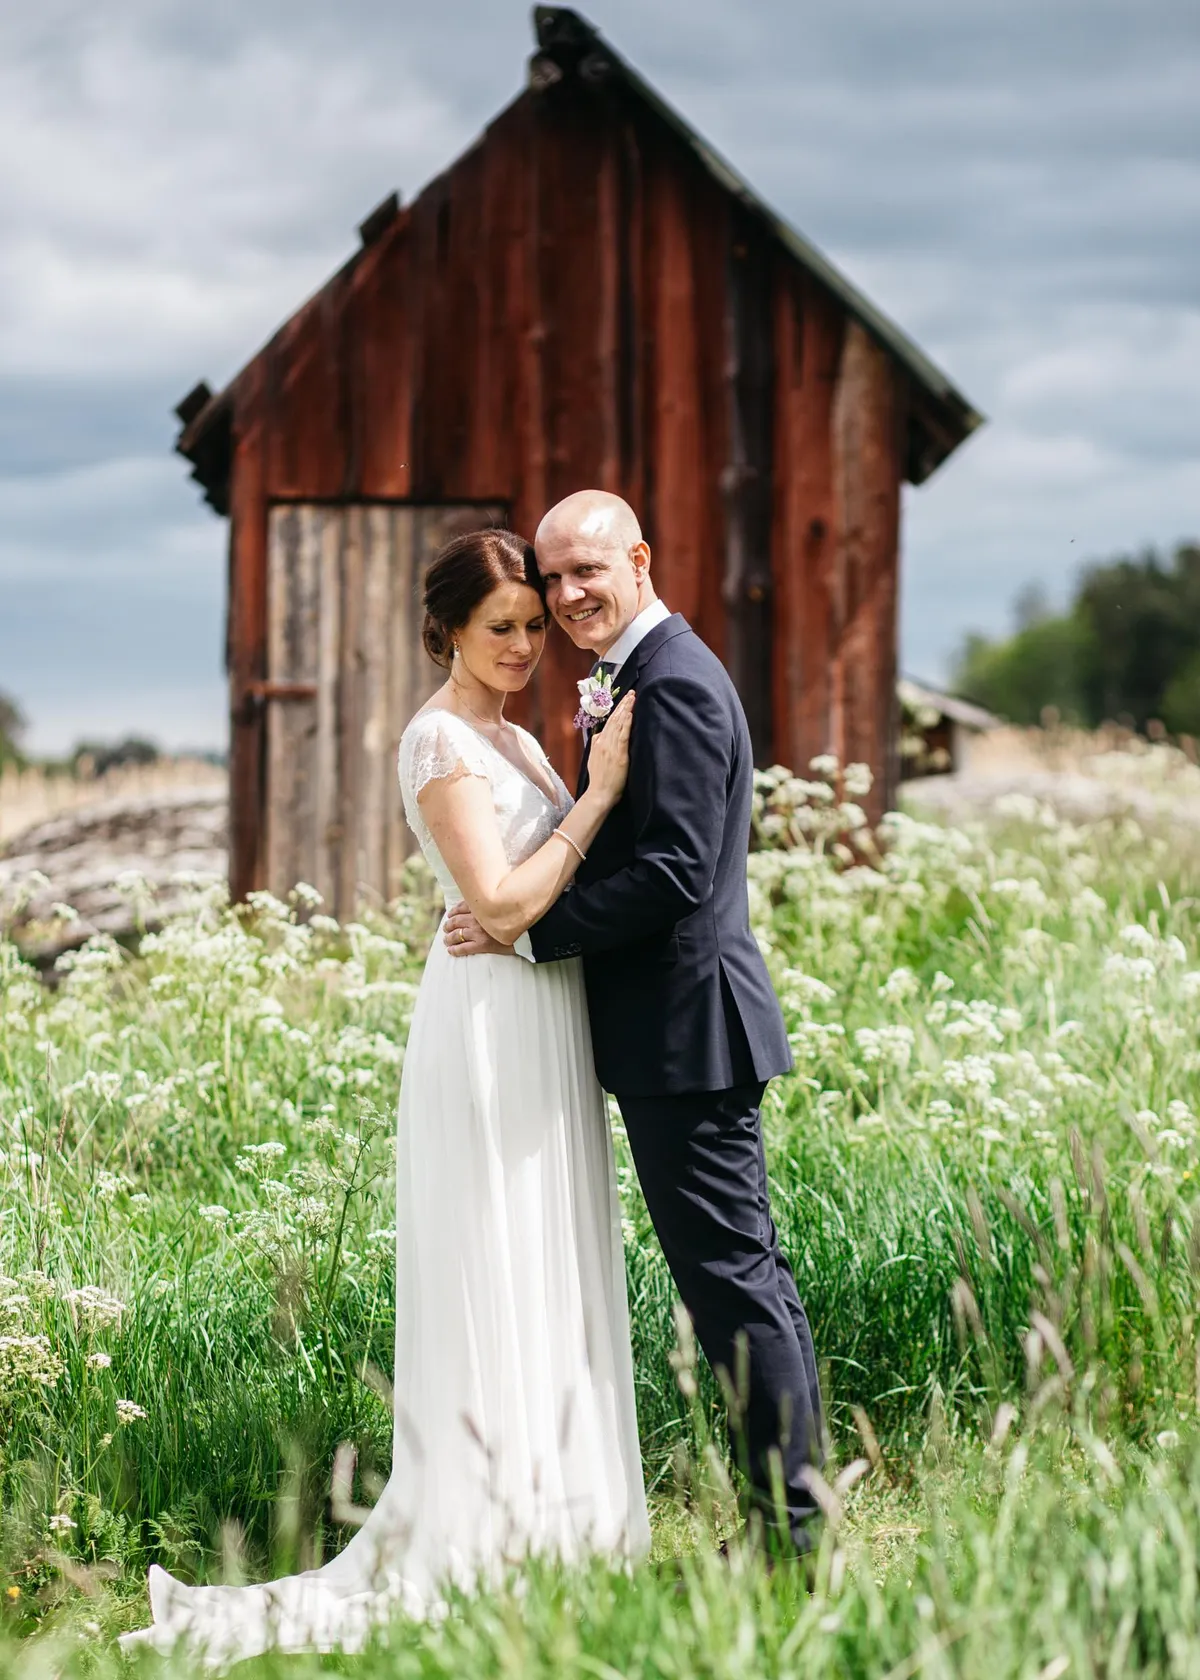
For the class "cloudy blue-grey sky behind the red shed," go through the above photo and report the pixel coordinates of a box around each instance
[0,0,1200,751]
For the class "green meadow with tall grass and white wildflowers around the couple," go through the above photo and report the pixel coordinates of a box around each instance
[0,749,1200,1680]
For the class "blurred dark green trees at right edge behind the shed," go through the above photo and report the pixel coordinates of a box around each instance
[955,543,1200,736]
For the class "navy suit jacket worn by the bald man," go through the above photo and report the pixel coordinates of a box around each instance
[529,613,792,1097]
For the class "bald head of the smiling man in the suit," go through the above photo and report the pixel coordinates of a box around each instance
[533,491,654,654]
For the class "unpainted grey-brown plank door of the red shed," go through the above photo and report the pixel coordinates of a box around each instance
[262,502,506,919]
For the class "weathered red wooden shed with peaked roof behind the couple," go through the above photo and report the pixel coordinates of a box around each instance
[178,7,980,916]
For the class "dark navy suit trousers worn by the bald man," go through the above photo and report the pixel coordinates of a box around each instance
[615,1084,824,1551]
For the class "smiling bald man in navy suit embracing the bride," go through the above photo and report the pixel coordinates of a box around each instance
[445,491,822,1551]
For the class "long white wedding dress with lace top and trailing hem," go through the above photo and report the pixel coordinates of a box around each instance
[121,709,650,1667]
